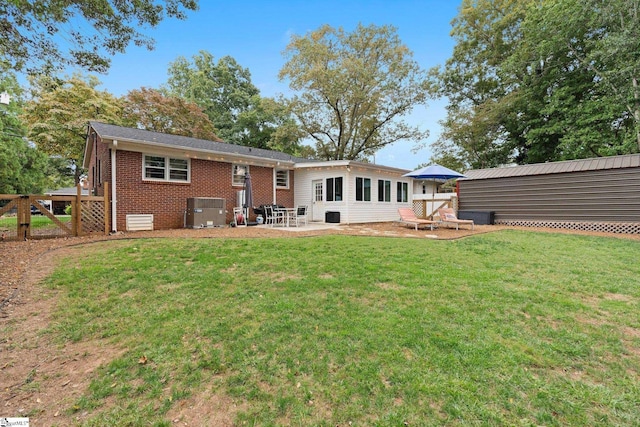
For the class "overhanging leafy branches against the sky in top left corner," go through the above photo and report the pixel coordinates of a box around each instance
[0,0,198,74]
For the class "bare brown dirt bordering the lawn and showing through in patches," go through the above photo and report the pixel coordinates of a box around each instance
[0,223,640,426]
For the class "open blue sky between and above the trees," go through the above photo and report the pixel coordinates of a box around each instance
[98,0,460,170]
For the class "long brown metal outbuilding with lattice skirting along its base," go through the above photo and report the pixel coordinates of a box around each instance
[458,154,640,233]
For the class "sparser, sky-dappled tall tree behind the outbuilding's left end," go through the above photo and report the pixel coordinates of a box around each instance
[430,0,530,168]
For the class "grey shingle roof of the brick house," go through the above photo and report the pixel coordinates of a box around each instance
[89,122,311,166]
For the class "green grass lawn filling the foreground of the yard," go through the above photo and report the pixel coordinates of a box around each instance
[47,231,640,426]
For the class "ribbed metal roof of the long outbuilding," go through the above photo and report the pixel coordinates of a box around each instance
[461,154,640,180]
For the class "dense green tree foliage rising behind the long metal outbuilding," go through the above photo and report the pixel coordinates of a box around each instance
[431,0,640,168]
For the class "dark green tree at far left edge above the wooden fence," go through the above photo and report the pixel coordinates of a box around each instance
[0,70,48,194]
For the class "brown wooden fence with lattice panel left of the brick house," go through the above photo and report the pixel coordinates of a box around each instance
[0,184,110,240]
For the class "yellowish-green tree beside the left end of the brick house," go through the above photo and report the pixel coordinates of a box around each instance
[23,75,122,185]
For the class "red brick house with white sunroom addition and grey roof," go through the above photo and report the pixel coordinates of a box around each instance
[83,122,412,231]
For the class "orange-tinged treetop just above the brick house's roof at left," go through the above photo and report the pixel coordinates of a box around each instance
[122,88,220,141]
